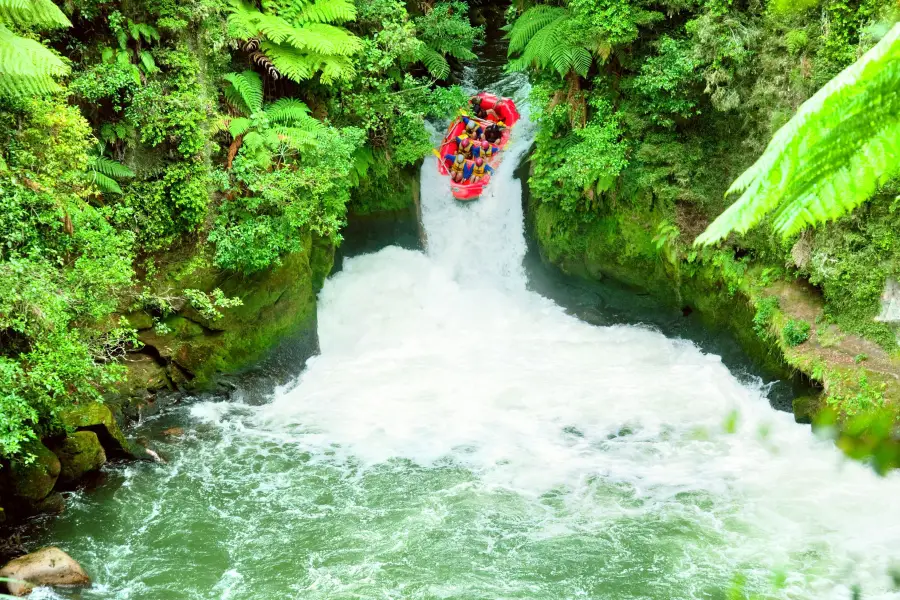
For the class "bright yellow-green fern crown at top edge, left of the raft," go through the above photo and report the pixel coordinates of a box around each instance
[228,0,361,83]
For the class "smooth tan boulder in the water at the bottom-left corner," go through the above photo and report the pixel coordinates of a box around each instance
[0,546,91,596]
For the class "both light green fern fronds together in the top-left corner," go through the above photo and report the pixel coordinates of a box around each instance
[0,0,72,98]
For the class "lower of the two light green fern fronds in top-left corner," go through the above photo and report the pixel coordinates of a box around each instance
[0,23,69,98]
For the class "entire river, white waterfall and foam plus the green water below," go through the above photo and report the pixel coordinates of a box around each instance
[26,72,900,600]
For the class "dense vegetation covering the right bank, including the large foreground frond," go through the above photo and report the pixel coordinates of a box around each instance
[506,0,900,468]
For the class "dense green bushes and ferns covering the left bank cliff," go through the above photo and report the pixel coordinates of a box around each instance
[0,0,481,458]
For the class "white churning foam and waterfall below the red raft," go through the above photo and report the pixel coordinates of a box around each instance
[248,86,900,598]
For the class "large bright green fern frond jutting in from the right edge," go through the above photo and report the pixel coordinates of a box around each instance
[696,24,900,244]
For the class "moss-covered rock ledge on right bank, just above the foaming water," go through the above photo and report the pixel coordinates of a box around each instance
[531,196,900,419]
